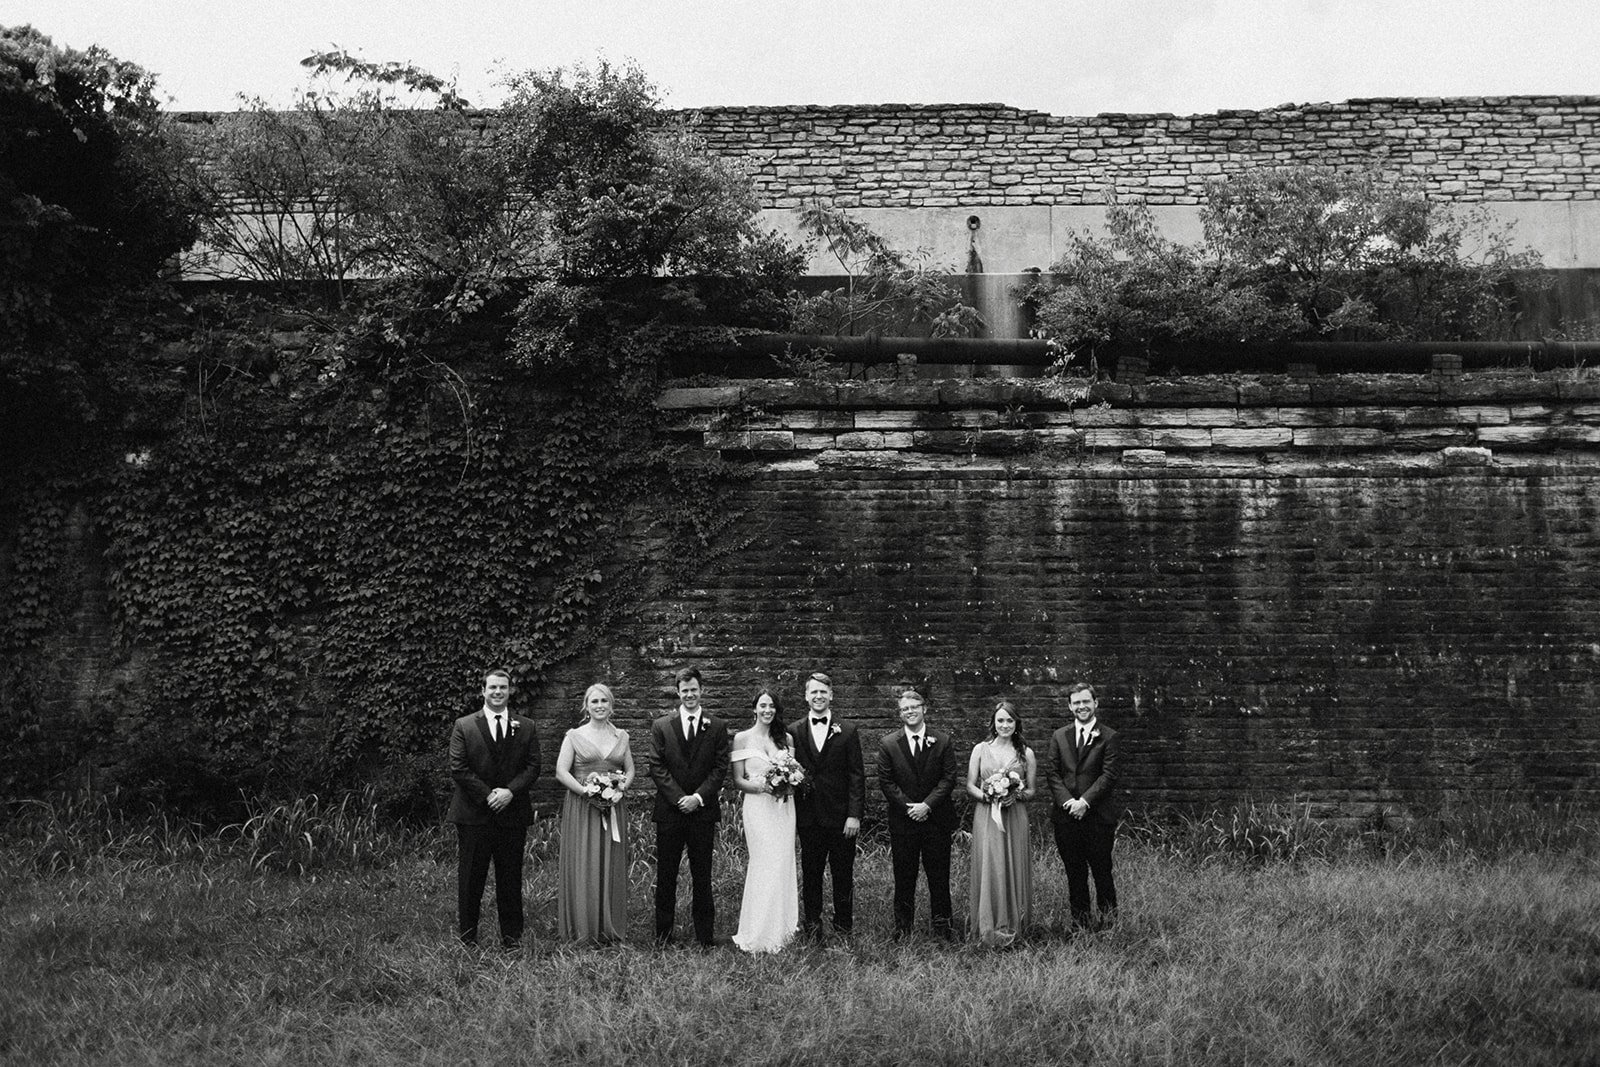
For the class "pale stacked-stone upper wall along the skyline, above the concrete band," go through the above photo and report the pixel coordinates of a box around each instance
[691,96,1600,208]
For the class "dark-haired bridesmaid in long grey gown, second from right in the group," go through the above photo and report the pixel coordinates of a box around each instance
[966,701,1037,947]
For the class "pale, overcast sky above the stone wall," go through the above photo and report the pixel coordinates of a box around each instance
[12,0,1600,115]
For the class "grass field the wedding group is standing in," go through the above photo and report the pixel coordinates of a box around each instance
[0,800,1600,1065]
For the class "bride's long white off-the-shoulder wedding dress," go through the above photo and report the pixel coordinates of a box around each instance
[730,749,800,952]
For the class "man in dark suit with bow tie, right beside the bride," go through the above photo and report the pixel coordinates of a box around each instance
[789,673,867,939]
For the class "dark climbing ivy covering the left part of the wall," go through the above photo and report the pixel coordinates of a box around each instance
[6,295,726,816]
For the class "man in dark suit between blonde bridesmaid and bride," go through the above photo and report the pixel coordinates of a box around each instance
[650,667,733,949]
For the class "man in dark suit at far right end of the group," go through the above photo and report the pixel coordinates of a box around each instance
[1046,681,1122,929]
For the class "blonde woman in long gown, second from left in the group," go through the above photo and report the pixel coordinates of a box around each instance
[555,685,634,944]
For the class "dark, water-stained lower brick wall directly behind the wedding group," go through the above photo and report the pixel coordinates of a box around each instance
[534,374,1600,817]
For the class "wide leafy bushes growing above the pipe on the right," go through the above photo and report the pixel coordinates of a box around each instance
[1027,166,1539,363]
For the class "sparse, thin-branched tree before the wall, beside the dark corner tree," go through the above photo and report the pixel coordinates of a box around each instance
[195,50,538,318]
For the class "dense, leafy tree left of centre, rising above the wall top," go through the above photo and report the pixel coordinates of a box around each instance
[494,61,803,376]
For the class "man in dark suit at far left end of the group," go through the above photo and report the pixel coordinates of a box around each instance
[448,667,539,949]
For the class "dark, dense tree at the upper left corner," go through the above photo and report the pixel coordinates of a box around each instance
[0,26,202,480]
